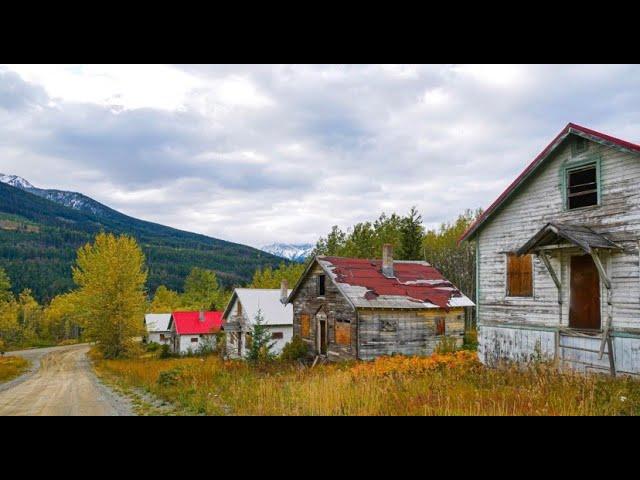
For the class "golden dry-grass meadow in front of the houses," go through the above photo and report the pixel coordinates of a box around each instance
[94,351,640,415]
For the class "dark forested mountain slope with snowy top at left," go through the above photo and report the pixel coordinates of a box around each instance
[0,175,282,301]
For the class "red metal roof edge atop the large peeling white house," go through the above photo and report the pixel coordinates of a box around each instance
[458,123,640,242]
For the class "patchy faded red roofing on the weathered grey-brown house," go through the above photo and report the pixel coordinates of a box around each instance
[319,257,461,309]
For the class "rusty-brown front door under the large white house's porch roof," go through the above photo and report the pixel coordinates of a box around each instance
[569,255,600,330]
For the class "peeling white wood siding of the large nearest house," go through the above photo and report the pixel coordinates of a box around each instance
[476,137,640,371]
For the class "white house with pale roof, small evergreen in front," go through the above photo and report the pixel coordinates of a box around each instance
[222,281,293,358]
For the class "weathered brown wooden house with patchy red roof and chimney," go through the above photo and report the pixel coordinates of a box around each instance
[288,245,473,360]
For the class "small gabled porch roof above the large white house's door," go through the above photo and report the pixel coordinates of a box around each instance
[516,222,620,255]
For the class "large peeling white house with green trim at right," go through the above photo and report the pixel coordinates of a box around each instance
[461,124,640,374]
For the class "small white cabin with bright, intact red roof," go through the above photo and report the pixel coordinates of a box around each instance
[169,312,222,355]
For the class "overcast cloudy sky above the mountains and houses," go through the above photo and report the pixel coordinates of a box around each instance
[0,65,640,246]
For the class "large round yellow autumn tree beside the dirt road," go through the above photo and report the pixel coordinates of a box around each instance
[73,233,147,358]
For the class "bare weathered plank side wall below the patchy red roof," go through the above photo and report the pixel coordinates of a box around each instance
[358,308,464,360]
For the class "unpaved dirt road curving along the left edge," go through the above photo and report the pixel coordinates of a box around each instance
[0,345,132,416]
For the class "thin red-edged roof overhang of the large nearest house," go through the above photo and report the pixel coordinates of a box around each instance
[458,123,640,243]
